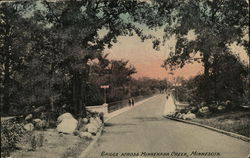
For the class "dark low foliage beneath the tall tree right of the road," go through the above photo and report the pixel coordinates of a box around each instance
[174,54,249,110]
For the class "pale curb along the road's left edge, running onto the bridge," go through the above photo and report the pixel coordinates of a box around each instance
[78,95,158,158]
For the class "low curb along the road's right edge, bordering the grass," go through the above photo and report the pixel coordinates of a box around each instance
[163,116,250,142]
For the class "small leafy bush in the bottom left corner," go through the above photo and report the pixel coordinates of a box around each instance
[1,120,24,157]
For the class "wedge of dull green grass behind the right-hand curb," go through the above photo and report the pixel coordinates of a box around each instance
[192,111,250,137]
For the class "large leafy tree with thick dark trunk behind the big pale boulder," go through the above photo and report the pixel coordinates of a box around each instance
[1,0,156,115]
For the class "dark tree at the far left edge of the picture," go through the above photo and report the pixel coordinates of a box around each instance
[0,3,31,112]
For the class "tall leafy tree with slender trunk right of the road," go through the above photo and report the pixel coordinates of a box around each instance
[156,0,249,101]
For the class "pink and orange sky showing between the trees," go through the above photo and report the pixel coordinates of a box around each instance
[104,27,248,80]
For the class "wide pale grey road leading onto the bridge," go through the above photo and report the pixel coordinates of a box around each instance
[84,95,250,158]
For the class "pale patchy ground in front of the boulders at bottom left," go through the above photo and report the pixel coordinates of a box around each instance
[11,129,91,158]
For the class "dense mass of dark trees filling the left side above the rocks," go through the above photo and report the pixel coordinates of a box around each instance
[0,0,168,115]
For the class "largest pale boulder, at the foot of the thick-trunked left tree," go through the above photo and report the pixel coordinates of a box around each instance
[56,118,78,134]
